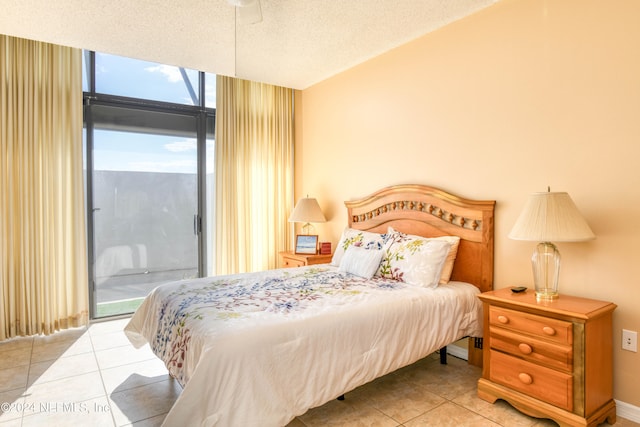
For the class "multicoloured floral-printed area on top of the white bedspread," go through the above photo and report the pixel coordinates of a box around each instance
[150,267,405,385]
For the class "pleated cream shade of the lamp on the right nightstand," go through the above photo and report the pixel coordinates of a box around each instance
[509,192,596,242]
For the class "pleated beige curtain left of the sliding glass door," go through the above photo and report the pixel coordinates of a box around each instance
[0,35,88,339]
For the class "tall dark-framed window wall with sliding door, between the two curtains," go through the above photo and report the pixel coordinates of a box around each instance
[83,52,215,318]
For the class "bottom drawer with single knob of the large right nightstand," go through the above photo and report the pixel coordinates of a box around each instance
[490,350,573,411]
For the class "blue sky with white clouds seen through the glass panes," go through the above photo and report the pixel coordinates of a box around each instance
[84,52,216,173]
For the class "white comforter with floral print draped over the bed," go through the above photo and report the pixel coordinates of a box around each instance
[125,265,482,427]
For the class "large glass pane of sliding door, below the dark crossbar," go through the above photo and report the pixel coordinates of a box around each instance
[92,127,199,317]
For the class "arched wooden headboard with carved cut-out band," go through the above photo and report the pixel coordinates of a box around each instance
[345,184,495,292]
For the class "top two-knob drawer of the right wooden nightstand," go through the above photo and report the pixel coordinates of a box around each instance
[489,306,573,345]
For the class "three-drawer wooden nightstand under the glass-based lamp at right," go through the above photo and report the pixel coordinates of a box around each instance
[478,288,616,426]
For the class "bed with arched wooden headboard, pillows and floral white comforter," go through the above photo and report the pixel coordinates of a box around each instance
[125,185,495,426]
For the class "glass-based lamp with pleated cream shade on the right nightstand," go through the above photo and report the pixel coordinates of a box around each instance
[509,191,596,300]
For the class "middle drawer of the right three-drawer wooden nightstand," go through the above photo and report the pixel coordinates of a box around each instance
[489,327,573,373]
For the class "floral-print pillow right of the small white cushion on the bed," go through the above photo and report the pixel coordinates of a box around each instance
[377,232,451,288]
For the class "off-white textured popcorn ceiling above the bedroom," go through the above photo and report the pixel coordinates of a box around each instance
[0,0,498,89]
